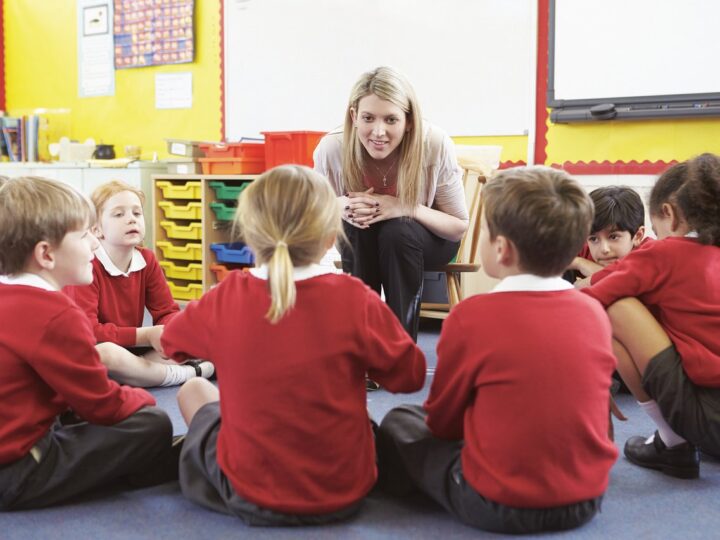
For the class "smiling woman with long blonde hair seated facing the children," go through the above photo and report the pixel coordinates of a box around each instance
[314,67,468,339]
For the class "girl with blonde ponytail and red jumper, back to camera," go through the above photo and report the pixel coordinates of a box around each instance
[162,166,425,525]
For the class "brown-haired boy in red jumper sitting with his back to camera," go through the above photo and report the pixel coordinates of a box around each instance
[377,167,617,533]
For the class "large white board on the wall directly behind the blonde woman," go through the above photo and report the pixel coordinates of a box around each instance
[223,0,537,140]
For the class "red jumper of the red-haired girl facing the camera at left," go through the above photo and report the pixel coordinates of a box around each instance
[64,248,180,347]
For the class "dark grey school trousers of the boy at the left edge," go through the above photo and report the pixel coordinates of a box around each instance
[0,407,172,510]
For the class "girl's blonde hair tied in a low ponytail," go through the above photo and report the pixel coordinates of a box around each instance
[234,165,342,323]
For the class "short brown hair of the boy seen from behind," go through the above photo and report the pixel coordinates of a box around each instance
[483,166,594,277]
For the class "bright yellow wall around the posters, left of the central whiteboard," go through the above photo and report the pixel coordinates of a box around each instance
[3,0,221,159]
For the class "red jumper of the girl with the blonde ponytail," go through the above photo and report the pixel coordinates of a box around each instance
[162,272,425,514]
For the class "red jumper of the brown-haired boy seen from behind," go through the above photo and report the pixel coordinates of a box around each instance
[425,289,617,508]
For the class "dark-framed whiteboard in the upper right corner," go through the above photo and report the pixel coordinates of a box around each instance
[548,0,720,121]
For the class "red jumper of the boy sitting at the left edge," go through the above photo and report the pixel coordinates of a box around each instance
[0,284,155,465]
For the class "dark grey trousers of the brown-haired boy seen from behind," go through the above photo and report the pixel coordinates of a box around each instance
[376,405,602,534]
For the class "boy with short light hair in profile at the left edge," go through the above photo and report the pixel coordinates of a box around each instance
[0,177,172,510]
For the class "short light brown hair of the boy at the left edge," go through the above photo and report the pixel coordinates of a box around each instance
[0,176,95,274]
